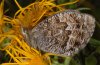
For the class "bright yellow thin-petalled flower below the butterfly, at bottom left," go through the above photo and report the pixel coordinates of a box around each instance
[0,35,49,65]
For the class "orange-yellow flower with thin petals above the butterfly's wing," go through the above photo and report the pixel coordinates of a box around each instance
[15,0,79,29]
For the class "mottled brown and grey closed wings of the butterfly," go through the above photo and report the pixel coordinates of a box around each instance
[22,10,95,56]
